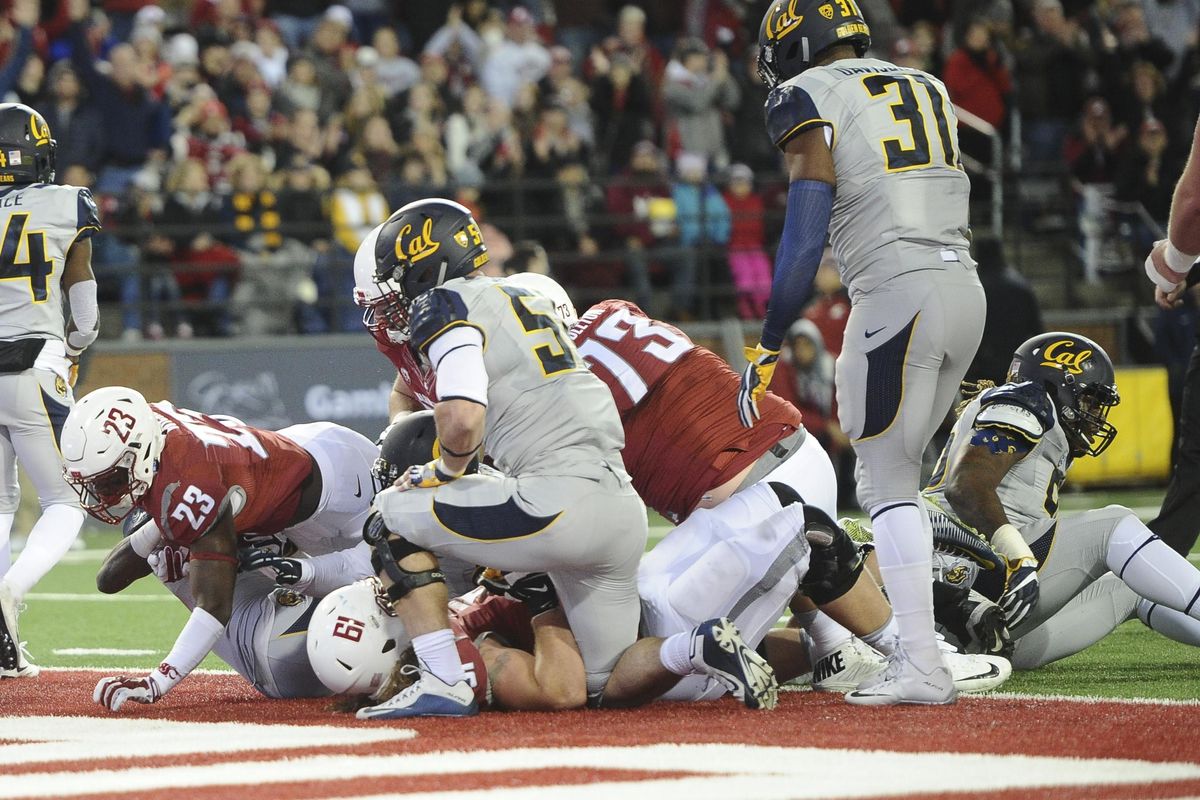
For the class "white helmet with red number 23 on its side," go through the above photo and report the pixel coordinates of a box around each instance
[59,386,166,525]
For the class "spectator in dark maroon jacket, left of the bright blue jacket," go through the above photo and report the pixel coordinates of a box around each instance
[606,142,681,315]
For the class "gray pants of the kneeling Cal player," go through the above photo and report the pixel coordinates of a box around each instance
[374,465,647,697]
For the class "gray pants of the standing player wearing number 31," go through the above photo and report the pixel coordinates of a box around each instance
[835,263,986,511]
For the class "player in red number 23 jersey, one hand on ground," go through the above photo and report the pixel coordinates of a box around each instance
[55,386,378,711]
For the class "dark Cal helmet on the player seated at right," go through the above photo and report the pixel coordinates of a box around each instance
[1008,331,1121,458]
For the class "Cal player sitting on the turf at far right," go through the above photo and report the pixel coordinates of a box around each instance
[924,332,1200,668]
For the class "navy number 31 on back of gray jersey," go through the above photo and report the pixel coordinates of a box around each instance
[863,74,959,173]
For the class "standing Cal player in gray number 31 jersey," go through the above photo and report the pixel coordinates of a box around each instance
[737,0,985,705]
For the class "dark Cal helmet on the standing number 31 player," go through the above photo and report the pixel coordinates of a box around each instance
[758,0,871,88]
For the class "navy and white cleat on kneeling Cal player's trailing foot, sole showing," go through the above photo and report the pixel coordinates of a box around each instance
[690,616,779,710]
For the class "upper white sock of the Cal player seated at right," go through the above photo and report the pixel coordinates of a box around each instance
[1105,516,1200,619]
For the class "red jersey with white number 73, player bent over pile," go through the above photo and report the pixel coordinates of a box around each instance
[571,300,800,523]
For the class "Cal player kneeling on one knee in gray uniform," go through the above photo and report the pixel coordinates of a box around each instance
[348,199,776,718]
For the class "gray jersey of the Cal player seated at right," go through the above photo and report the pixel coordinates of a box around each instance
[925,384,1070,533]
